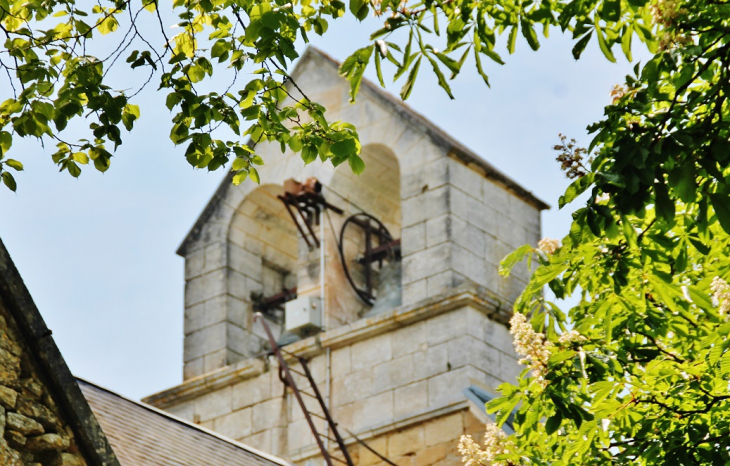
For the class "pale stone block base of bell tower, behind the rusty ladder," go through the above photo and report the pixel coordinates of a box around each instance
[145,300,520,465]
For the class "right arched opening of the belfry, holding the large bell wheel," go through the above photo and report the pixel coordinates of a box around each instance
[325,144,401,324]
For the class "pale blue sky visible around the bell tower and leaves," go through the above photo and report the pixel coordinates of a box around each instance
[0,9,645,398]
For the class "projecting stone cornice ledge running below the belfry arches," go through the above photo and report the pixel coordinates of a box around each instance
[142,284,510,409]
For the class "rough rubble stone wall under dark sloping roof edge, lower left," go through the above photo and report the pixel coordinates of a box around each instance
[0,301,86,466]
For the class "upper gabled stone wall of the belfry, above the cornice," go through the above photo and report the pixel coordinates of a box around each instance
[173,48,545,380]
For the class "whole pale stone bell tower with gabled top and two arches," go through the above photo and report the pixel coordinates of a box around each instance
[145,47,547,466]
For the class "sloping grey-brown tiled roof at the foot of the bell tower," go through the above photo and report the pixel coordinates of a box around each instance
[78,379,291,466]
